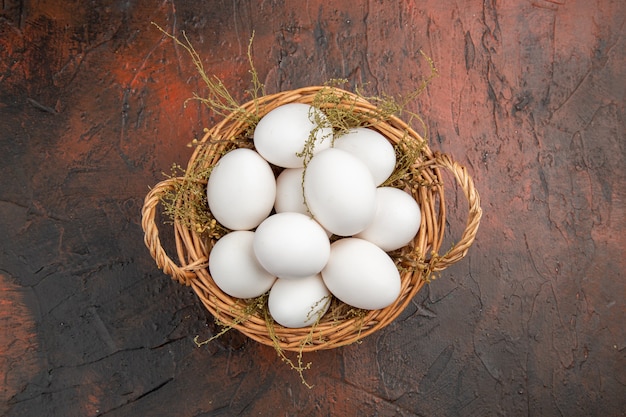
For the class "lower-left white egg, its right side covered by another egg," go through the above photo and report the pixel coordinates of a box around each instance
[209,230,276,298]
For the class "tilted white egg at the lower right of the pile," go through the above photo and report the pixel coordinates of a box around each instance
[322,238,401,310]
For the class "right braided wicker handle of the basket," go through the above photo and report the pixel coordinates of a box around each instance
[428,152,482,271]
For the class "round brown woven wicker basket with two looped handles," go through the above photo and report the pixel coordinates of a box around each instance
[142,87,482,352]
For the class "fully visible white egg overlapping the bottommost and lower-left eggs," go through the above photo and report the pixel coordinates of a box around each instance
[253,212,330,279]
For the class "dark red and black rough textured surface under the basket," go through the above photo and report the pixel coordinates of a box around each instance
[0,0,626,417]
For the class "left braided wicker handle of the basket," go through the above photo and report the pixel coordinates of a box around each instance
[141,177,196,285]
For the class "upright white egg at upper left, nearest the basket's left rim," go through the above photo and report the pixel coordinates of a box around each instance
[207,148,276,230]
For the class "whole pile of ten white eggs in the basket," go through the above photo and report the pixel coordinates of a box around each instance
[207,103,421,328]
